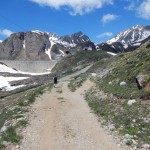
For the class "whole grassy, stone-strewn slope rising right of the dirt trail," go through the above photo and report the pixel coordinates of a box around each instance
[85,47,150,149]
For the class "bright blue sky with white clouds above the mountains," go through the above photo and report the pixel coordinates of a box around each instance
[0,0,150,43]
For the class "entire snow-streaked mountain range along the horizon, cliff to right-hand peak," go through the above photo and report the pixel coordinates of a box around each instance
[0,25,150,60]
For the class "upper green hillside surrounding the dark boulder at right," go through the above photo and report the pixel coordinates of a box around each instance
[96,49,150,99]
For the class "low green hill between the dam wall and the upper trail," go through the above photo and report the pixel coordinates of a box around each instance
[52,51,111,75]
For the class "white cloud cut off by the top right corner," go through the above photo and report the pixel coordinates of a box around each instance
[137,0,150,20]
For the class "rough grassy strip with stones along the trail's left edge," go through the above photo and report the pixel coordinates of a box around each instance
[0,84,49,149]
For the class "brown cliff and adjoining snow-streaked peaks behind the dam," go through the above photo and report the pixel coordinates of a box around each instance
[0,31,90,60]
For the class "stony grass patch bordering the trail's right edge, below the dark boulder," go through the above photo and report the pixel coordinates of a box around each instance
[85,89,150,147]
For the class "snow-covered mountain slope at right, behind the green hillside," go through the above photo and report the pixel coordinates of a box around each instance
[98,25,150,53]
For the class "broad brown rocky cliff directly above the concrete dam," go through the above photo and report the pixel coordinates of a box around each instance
[0,32,51,60]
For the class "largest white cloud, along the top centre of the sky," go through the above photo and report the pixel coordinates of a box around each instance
[29,0,113,15]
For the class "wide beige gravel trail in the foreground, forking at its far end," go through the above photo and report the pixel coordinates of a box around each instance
[9,77,126,150]
